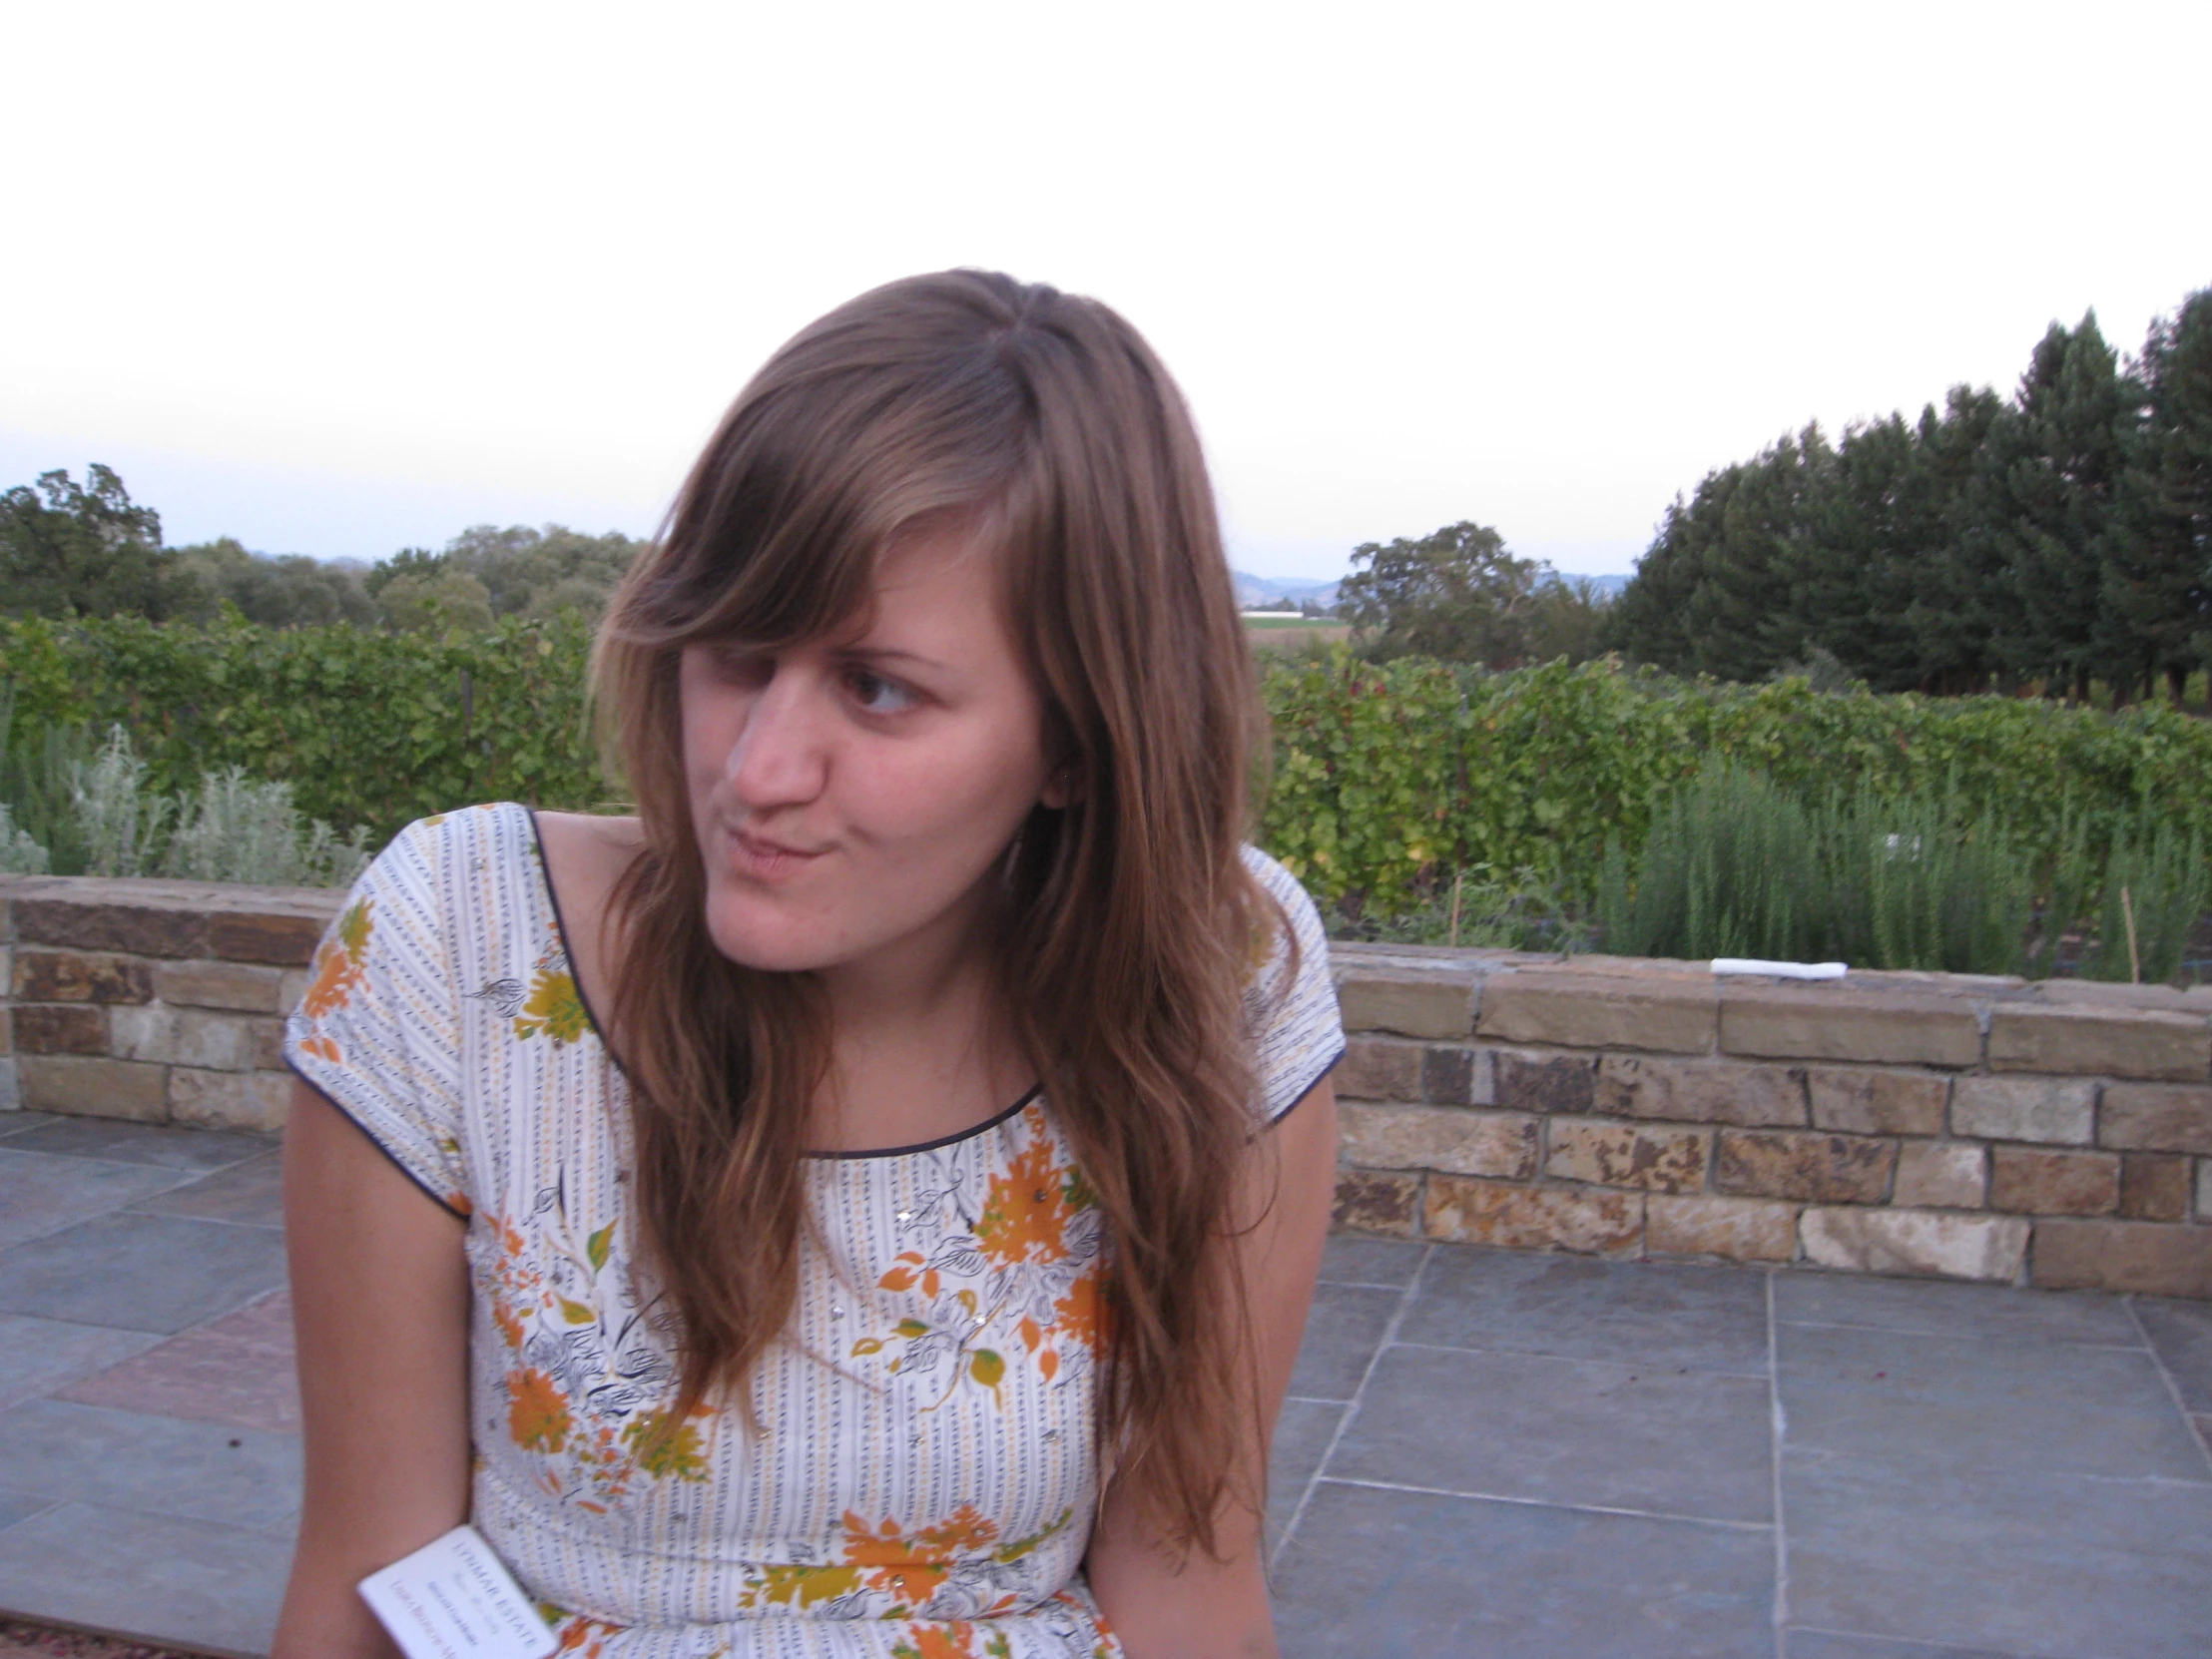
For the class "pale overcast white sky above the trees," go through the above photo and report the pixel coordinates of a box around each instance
[0,0,2212,575]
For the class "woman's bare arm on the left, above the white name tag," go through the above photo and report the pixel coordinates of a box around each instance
[273,1082,469,1659]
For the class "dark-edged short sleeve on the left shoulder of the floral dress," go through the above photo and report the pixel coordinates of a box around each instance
[283,819,473,1215]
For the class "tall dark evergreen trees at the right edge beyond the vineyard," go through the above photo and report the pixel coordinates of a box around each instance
[1604,287,2212,704]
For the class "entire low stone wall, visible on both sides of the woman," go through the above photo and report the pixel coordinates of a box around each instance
[0,876,2212,1297]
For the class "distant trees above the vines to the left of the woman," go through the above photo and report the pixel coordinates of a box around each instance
[0,464,642,631]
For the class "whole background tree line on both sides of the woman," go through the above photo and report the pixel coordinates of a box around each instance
[13,276,2212,704]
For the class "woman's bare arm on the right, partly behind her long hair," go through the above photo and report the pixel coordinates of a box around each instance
[1086,1077,1336,1659]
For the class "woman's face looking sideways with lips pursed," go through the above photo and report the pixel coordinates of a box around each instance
[679,533,1062,971]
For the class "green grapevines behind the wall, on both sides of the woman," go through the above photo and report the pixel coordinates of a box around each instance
[0,615,2212,959]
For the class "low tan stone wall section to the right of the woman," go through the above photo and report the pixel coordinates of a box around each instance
[1334,946,2212,1297]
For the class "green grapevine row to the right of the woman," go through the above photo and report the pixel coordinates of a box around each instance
[1261,653,2212,913]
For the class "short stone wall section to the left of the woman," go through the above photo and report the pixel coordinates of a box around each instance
[0,876,340,1130]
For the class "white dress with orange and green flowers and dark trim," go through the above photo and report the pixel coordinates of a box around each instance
[285,806,1343,1659]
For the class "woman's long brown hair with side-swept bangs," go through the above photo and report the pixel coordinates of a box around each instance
[595,270,1272,1548]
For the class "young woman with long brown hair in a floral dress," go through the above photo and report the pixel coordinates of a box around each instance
[276,273,1343,1659]
